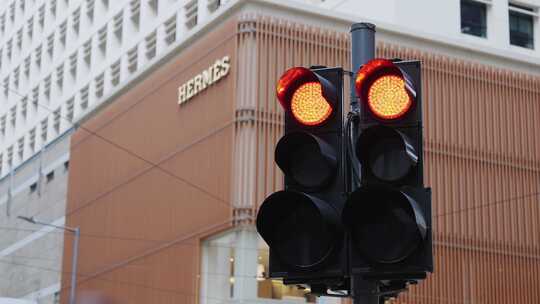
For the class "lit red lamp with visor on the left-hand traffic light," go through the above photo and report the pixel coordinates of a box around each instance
[277,67,336,126]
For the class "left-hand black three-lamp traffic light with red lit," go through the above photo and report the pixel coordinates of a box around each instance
[256,67,346,292]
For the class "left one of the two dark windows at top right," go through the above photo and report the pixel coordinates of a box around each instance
[461,0,487,37]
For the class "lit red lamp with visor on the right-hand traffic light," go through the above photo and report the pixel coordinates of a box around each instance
[355,59,416,120]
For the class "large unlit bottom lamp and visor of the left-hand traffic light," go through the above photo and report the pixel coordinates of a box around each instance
[256,191,340,269]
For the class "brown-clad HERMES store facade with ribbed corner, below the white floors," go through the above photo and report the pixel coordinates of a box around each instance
[62,4,540,303]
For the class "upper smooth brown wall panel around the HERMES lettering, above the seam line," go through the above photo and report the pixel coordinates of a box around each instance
[66,19,236,214]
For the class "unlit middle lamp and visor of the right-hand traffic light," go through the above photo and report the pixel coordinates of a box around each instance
[356,126,418,182]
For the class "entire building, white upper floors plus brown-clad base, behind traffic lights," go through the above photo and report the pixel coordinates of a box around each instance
[0,0,540,303]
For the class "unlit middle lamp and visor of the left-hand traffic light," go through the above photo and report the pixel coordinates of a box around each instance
[275,132,337,188]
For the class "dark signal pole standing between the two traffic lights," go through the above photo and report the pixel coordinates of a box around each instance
[349,22,380,304]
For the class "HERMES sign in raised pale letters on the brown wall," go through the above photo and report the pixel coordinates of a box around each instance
[178,56,231,105]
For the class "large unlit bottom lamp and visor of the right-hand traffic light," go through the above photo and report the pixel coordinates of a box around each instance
[343,187,427,264]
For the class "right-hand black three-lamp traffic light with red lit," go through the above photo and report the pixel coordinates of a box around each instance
[342,59,433,281]
